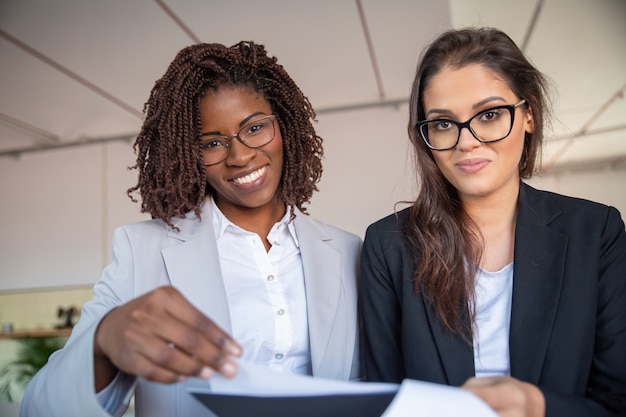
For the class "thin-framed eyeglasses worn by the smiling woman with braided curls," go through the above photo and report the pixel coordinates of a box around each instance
[200,114,276,165]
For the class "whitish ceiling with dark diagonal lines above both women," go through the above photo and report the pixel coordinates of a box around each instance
[0,0,626,169]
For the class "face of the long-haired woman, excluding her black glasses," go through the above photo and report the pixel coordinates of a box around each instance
[423,64,533,201]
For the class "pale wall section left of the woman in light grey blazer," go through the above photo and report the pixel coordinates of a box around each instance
[0,142,145,291]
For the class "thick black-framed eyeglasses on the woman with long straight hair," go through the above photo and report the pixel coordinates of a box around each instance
[415,99,526,151]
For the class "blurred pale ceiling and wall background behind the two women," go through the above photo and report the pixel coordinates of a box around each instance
[0,0,626,406]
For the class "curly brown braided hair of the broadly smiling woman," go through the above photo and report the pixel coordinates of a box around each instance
[127,41,323,226]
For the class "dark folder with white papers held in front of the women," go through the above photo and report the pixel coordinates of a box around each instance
[190,361,497,417]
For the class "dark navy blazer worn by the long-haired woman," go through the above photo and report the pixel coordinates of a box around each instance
[360,183,626,417]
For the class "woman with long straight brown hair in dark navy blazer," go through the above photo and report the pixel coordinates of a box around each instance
[361,28,626,417]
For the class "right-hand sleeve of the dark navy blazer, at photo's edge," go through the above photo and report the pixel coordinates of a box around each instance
[539,207,626,417]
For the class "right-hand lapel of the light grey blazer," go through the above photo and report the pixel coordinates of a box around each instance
[294,212,346,378]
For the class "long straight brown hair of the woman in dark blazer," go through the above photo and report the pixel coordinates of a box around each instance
[405,28,547,340]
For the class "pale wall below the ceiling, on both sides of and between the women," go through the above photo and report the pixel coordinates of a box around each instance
[0,106,626,291]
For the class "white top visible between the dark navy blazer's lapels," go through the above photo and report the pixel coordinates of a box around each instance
[474,263,513,377]
